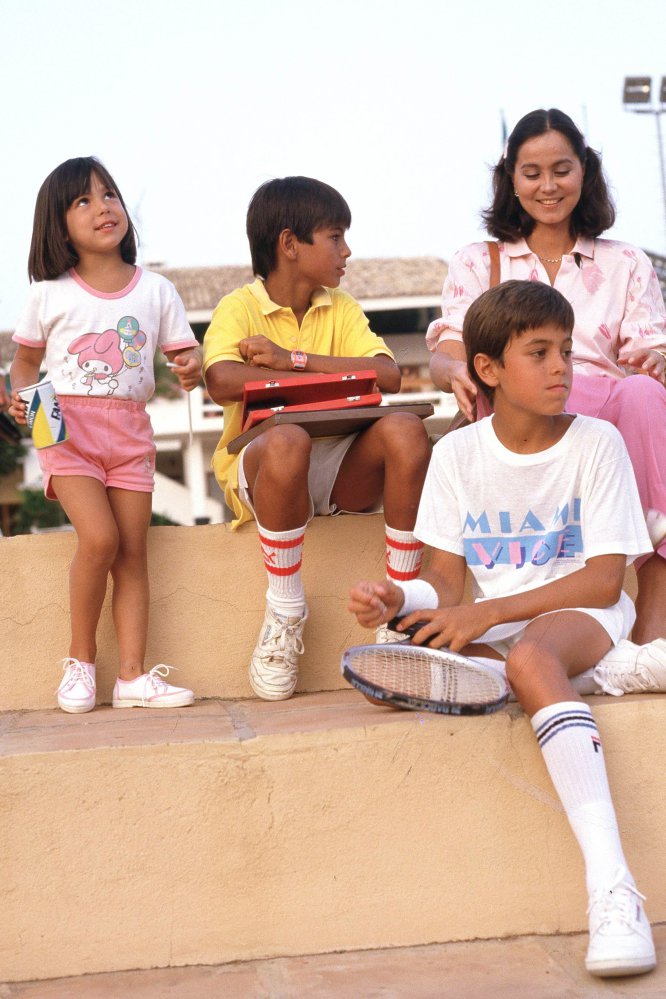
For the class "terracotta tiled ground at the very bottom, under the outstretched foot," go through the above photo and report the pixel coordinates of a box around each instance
[5,925,666,999]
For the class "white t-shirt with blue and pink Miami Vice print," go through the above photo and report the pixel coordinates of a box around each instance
[414,416,652,599]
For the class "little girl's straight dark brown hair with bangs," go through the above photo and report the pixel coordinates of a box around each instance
[28,156,138,281]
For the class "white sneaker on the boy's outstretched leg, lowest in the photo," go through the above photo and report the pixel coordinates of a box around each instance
[585,867,657,978]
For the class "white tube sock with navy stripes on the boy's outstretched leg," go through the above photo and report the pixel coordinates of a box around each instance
[532,701,627,892]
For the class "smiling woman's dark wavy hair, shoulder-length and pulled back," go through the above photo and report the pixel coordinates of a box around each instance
[481,108,615,243]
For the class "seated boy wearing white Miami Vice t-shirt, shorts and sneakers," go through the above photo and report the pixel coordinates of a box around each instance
[349,281,666,977]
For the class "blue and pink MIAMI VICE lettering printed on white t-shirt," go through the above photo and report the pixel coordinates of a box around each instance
[464,497,583,569]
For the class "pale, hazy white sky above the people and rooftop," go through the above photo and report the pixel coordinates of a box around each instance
[0,0,666,330]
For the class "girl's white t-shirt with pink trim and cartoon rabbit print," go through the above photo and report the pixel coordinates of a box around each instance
[12,267,197,402]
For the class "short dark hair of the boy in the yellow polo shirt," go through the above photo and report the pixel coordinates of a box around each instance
[246,177,351,278]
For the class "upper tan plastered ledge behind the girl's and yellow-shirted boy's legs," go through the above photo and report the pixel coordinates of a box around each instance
[0,516,385,711]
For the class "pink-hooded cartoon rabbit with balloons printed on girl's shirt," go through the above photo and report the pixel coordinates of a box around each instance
[68,316,146,396]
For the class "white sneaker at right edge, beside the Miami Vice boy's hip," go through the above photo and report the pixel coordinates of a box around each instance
[594,638,666,697]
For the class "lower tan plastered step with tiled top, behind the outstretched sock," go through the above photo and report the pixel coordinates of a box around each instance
[0,690,666,981]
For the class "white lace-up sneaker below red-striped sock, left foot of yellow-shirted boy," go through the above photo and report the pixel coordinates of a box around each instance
[250,604,308,701]
